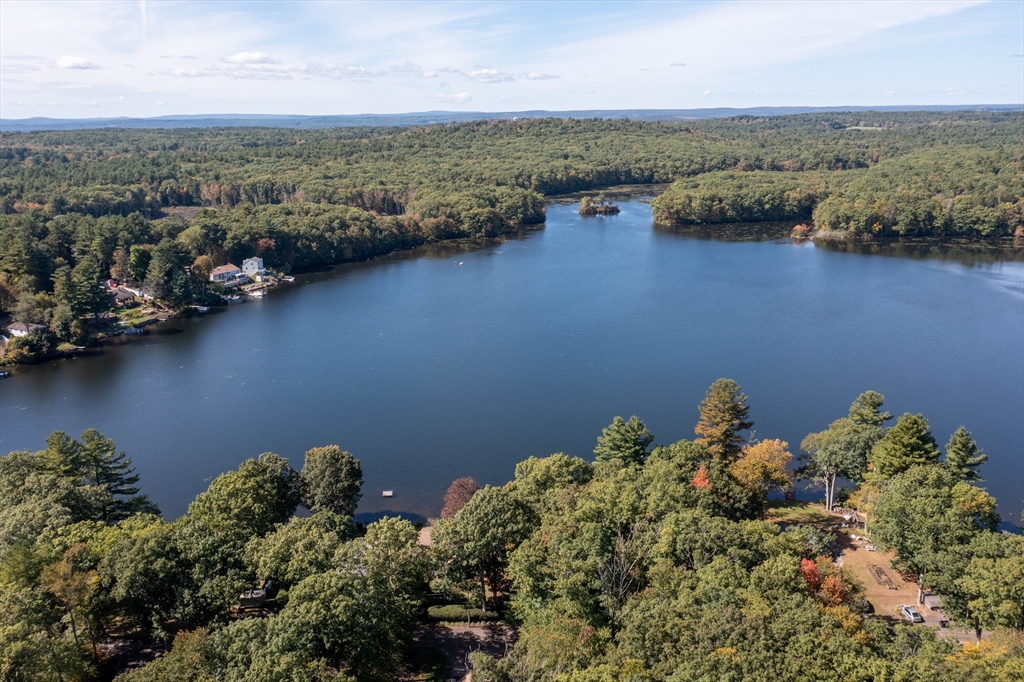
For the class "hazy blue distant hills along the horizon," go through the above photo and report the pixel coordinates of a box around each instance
[0,104,1024,132]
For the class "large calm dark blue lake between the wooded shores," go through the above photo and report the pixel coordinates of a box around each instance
[0,201,1024,523]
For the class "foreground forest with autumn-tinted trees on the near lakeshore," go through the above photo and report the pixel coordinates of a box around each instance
[0,379,1024,682]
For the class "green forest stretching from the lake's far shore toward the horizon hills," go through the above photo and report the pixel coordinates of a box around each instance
[0,112,1024,327]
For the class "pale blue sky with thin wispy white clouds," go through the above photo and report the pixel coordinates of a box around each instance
[0,0,1024,119]
